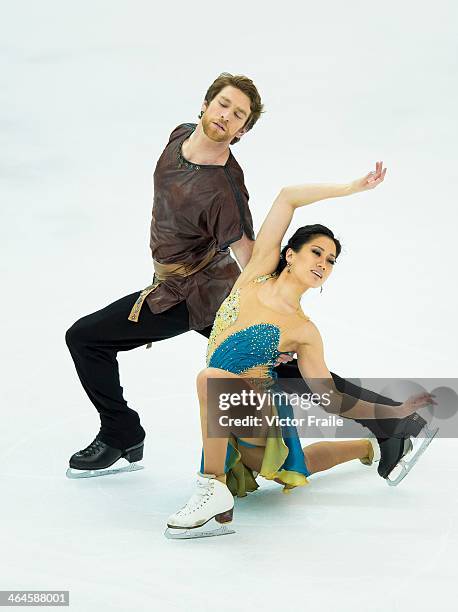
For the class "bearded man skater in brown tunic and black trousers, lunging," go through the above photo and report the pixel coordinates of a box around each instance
[65,73,425,477]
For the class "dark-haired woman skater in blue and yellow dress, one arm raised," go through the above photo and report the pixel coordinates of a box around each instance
[166,162,435,538]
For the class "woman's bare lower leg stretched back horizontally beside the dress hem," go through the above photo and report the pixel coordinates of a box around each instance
[303,440,373,474]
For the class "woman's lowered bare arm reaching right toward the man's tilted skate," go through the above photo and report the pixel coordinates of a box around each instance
[297,321,437,419]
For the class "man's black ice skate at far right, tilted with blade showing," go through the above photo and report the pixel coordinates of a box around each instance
[377,413,439,486]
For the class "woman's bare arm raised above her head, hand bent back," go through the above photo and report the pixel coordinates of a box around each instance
[234,162,386,287]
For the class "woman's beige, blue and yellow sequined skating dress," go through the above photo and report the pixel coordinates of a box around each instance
[201,273,310,496]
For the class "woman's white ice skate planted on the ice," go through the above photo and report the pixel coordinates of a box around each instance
[164,472,235,540]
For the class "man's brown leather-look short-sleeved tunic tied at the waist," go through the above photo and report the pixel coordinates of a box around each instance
[136,123,255,329]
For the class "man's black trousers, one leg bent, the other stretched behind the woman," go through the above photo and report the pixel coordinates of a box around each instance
[65,291,399,449]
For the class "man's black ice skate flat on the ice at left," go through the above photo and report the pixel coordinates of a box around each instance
[66,436,143,478]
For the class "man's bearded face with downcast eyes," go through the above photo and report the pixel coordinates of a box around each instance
[201,85,250,144]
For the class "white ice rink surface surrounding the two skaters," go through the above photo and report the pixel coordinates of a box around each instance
[0,0,458,612]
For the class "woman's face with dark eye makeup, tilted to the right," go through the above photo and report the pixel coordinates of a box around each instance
[286,236,336,287]
